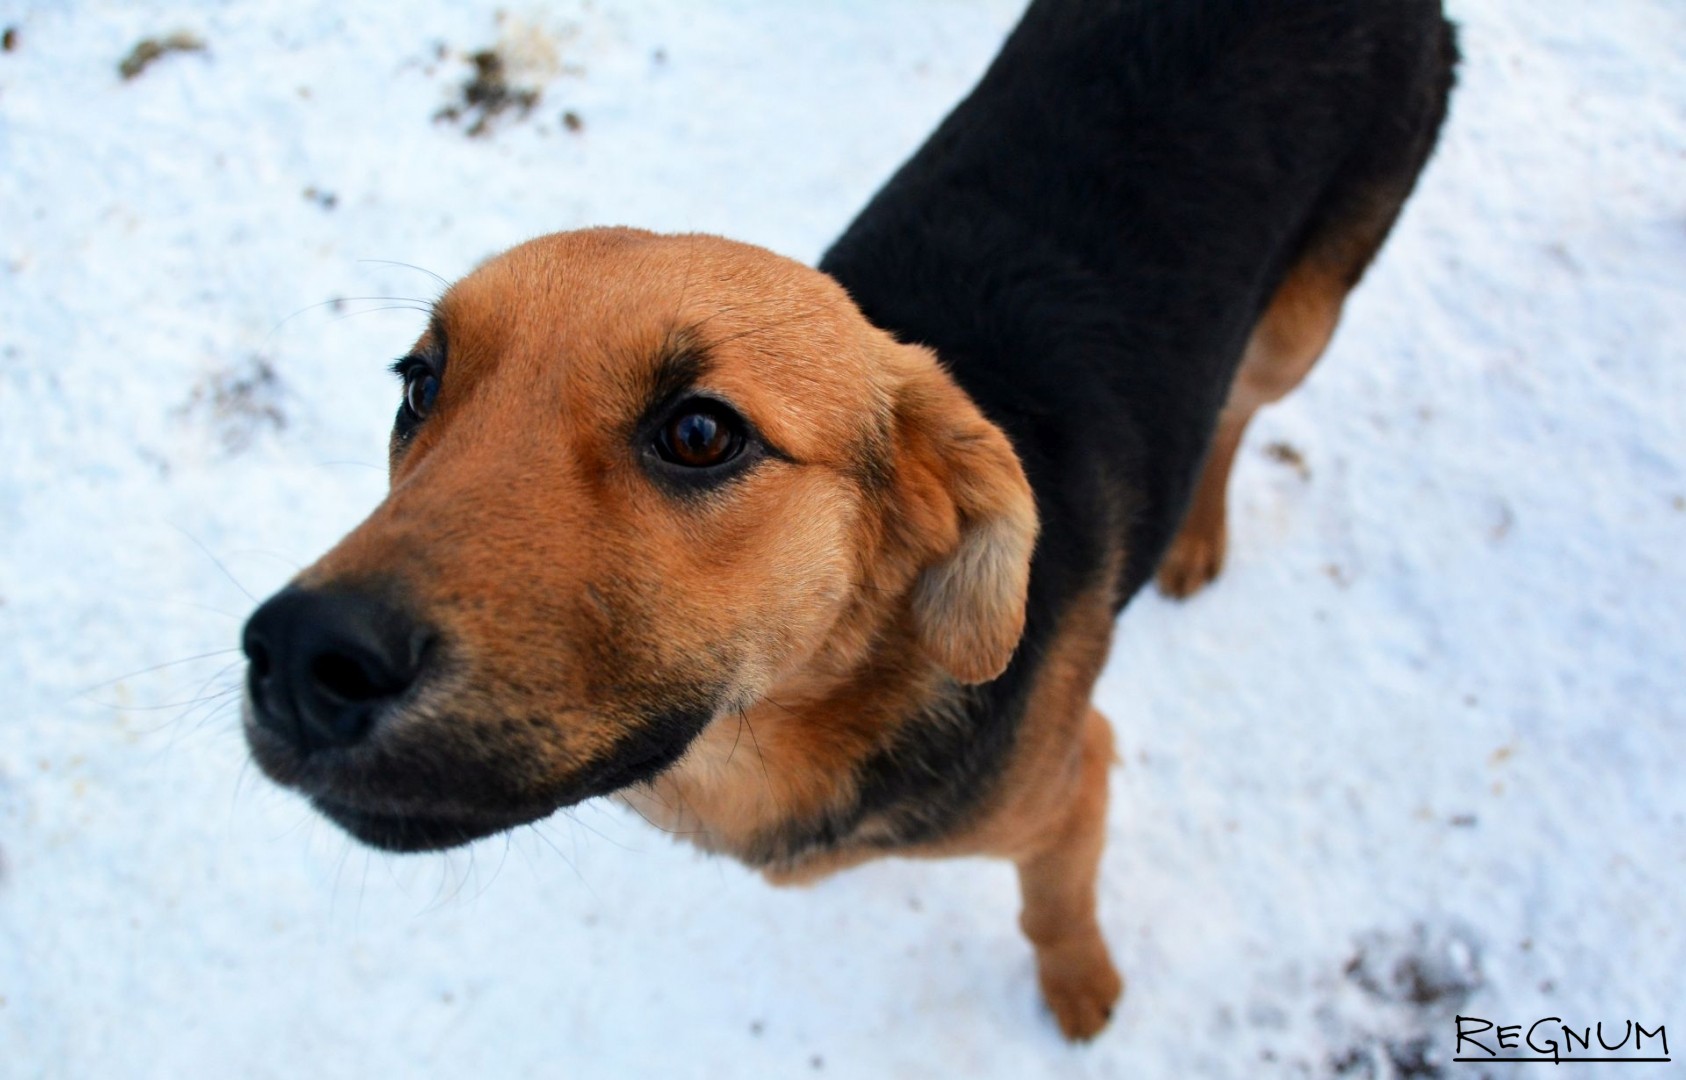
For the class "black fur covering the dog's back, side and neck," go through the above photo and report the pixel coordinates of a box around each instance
[769,0,1457,858]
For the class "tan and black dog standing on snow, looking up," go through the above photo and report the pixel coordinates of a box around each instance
[243,0,1457,1040]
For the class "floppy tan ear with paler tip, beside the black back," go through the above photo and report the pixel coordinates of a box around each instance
[892,345,1037,682]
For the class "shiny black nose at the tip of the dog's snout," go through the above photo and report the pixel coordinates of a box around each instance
[241,588,432,751]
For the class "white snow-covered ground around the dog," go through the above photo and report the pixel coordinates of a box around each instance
[0,0,1686,1078]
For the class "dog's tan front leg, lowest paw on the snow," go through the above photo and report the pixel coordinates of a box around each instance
[1018,708,1125,1040]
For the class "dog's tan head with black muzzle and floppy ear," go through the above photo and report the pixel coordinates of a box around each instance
[244,229,1035,849]
